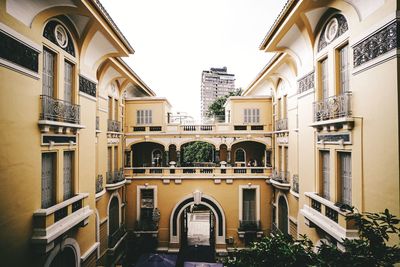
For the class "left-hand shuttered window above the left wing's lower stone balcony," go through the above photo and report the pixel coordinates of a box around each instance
[42,153,57,209]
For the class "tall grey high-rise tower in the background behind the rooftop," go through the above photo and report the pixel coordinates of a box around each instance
[201,67,235,119]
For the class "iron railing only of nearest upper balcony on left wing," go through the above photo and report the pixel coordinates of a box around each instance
[40,95,80,124]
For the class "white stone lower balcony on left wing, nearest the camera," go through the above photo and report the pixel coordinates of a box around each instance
[31,193,93,253]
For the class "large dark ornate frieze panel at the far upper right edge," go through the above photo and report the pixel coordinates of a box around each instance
[353,20,400,67]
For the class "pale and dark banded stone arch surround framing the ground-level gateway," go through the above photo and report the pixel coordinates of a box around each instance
[169,192,226,245]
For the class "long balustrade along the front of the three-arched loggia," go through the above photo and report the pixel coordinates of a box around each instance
[125,166,271,179]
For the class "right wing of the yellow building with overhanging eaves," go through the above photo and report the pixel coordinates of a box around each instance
[244,1,400,246]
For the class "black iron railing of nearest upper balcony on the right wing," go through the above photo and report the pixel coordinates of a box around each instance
[313,92,352,122]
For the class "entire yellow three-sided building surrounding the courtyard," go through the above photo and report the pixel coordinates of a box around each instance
[0,0,400,266]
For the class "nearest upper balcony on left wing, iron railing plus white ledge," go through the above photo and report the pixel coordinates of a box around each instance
[39,95,84,133]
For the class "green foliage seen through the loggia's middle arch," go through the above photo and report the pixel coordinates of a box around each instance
[183,141,214,163]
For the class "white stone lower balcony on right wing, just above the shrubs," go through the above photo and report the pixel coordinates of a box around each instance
[300,192,358,242]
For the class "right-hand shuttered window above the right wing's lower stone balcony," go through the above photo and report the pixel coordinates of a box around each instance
[338,152,351,205]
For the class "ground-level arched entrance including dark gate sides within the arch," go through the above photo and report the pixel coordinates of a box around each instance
[170,192,226,248]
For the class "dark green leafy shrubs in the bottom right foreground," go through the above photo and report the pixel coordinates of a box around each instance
[225,209,400,267]
